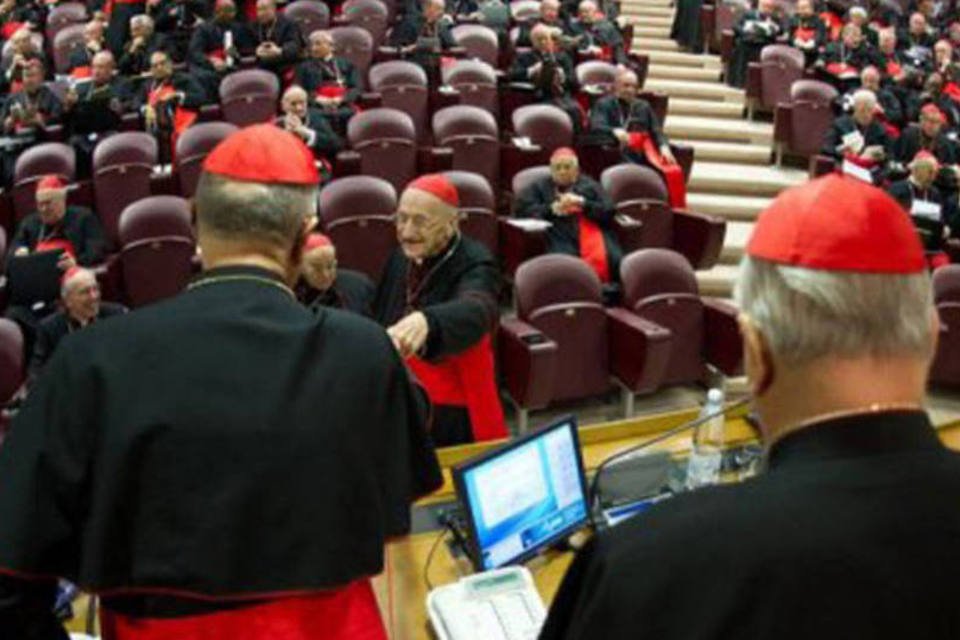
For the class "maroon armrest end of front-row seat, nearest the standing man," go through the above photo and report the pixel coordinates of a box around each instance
[497,318,559,409]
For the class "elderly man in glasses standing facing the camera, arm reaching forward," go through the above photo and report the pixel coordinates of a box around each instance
[373,174,507,446]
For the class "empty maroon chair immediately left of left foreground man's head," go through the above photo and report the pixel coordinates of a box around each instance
[119,196,196,307]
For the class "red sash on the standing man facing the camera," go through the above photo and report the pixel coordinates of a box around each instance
[407,335,507,442]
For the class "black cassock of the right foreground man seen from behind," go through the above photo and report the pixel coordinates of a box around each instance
[540,412,960,640]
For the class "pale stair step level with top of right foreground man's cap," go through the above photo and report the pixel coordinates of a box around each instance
[688,162,808,197]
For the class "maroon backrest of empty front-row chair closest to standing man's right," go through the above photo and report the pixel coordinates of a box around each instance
[514,254,610,401]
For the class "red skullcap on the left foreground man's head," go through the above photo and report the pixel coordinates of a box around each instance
[203,124,320,186]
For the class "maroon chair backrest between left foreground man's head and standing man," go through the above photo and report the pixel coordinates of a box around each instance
[319,176,397,282]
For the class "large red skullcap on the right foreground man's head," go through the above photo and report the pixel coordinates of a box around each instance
[746,174,926,274]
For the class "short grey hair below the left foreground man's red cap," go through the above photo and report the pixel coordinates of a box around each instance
[194,172,317,247]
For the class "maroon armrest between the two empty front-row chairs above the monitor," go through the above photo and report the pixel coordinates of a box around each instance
[607,307,673,393]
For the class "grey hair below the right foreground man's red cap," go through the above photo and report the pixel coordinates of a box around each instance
[734,256,935,365]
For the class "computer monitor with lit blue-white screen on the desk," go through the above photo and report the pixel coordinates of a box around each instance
[453,416,589,571]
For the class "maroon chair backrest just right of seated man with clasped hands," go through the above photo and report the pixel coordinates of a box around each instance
[600,163,673,247]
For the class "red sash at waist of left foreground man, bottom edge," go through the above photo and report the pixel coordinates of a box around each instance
[100,580,387,640]
